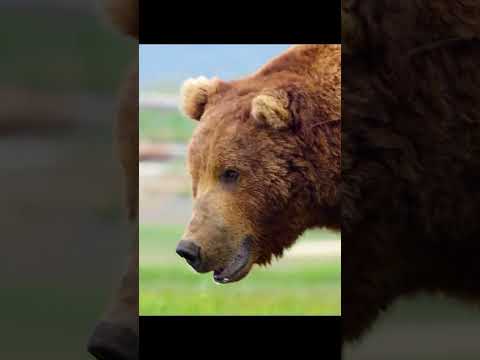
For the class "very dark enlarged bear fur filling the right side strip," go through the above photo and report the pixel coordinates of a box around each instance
[342,0,480,340]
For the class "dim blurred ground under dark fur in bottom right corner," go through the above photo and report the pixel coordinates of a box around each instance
[342,294,480,360]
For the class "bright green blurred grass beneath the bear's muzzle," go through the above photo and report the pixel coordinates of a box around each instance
[140,225,340,315]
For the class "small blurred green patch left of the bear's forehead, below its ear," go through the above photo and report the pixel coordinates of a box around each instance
[139,109,195,142]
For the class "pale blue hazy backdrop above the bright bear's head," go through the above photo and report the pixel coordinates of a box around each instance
[139,45,290,92]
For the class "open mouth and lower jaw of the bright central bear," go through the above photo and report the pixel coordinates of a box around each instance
[213,236,252,284]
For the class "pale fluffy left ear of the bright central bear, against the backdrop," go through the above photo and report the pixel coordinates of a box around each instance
[180,76,217,120]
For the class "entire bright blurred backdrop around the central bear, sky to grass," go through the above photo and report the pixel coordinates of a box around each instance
[139,45,341,315]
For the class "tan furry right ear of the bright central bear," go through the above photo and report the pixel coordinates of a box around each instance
[252,90,291,129]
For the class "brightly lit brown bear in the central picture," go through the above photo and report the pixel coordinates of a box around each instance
[177,45,341,283]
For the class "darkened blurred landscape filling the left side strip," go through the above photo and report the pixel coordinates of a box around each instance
[0,0,138,360]
